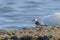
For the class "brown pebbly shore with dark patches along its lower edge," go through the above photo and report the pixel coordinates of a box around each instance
[0,27,60,40]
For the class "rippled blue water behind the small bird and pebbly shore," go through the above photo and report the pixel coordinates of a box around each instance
[0,0,60,30]
